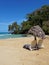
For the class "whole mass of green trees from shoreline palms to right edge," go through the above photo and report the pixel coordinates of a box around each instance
[8,5,49,34]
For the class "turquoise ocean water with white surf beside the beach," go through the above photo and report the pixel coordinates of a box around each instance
[0,32,26,39]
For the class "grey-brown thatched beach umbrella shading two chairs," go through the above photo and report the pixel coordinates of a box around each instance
[28,25,45,47]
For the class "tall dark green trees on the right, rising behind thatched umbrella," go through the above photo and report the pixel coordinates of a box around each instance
[27,5,49,34]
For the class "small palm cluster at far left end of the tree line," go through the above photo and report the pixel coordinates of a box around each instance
[8,22,19,34]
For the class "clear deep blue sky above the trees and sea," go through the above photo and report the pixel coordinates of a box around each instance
[0,0,49,32]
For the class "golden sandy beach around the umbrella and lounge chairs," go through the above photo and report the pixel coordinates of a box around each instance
[0,37,49,65]
